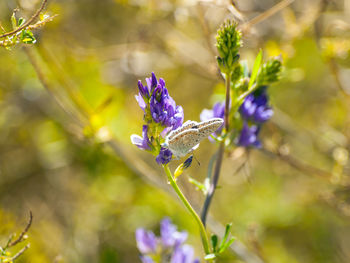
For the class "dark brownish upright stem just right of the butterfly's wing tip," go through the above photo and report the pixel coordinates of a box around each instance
[201,73,231,225]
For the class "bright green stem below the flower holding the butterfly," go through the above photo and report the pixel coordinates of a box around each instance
[163,164,210,255]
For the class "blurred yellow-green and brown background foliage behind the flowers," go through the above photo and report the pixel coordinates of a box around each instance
[0,0,350,263]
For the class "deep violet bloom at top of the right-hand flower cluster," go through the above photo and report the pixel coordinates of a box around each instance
[239,86,273,123]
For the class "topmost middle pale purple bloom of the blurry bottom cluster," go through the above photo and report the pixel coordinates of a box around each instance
[160,218,187,250]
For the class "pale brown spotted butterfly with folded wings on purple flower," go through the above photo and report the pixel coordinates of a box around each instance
[162,118,224,159]
